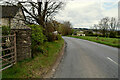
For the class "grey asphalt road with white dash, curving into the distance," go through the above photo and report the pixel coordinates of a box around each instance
[54,37,119,78]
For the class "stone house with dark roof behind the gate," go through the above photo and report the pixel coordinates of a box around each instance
[0,5,25,28]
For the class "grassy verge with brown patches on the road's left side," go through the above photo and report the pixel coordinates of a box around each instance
[2,39,64,78]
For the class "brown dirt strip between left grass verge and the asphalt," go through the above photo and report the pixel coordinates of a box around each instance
[43,40,66,78]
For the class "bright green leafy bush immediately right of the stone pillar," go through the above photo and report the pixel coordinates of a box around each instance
[29,25,46,53]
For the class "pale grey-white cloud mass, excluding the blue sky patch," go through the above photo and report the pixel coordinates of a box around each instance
[56,1,117,27]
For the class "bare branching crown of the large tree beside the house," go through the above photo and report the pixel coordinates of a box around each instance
[0,0,64,28]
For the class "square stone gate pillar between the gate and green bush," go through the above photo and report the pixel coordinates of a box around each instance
[11,29,31,61]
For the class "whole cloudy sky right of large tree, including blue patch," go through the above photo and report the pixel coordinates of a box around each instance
[55,0,119,28]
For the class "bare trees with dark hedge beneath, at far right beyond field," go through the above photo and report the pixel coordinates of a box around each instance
[93,17,120,37]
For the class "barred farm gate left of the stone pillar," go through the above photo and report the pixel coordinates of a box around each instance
[0,33,16,71]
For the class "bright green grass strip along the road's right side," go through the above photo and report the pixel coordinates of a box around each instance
[68,35,120,48]
